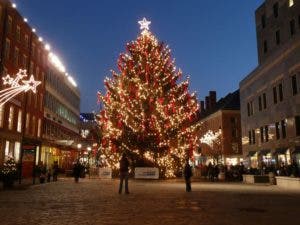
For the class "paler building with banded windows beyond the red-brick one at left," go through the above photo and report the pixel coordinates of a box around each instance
[40,61,80,170]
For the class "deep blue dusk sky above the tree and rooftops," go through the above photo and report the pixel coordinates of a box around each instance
[14,0,263,112]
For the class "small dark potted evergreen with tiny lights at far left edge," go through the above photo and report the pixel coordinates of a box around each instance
[0,157,17,188]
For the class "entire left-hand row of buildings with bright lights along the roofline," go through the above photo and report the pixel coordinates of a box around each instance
[0,0,80,177]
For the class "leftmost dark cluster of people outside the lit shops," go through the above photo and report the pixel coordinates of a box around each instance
[35,161,59,184]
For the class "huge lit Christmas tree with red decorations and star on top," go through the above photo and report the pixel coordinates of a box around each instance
[98,18,200,177]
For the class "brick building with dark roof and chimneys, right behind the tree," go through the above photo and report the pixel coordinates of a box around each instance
[195,91,243,166]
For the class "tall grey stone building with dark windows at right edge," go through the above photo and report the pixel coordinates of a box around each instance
[240,0,300,168]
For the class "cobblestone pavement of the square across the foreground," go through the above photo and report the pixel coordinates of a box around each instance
[0,178,300,225]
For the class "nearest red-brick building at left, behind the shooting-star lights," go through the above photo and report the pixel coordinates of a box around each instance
[0,0,46,164]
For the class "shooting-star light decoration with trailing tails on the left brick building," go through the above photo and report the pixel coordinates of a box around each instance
[0,69,41,107]
